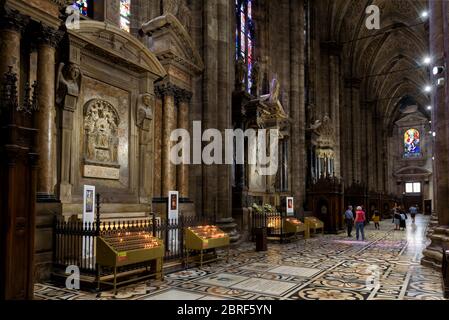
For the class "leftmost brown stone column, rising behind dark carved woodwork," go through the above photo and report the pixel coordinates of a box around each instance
[0,9,28,94]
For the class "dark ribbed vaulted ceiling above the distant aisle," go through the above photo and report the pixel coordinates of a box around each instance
[321,0,430,126]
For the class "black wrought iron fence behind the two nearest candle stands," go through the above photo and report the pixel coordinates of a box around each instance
[53,195,215,275]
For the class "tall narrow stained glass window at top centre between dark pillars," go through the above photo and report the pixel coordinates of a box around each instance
[235,0,254,91]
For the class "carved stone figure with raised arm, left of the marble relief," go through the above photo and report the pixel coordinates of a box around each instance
[56,62,81,110]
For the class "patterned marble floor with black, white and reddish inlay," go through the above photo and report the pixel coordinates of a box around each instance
[35,216,443,300]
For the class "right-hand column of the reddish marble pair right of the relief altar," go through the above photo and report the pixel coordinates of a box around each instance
[176,90,192,198]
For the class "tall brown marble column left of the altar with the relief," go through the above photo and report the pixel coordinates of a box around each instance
[37,25,61,201]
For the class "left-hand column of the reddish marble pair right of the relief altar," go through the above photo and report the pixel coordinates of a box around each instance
[160,84,177,197]
